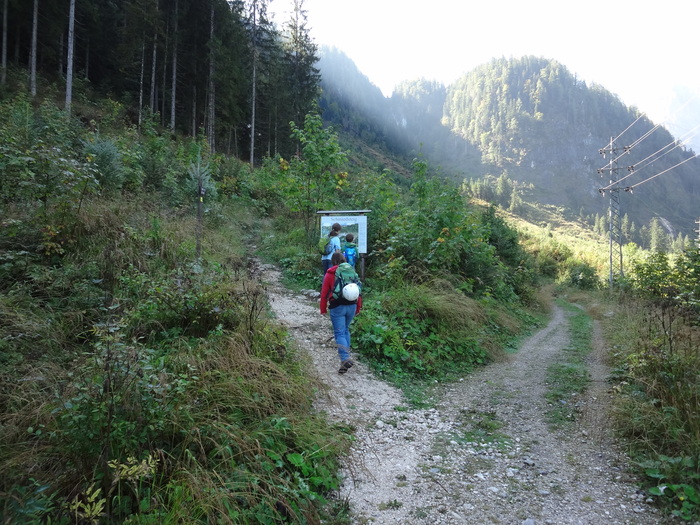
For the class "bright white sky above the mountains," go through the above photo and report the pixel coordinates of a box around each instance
[270,0,700,133]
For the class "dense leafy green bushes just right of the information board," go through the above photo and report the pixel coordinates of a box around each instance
[372,161,533,301]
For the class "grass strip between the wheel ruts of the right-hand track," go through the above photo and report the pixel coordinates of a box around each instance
[546,299,592,427]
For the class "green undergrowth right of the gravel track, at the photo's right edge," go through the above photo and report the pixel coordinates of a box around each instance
[605,286,700,521]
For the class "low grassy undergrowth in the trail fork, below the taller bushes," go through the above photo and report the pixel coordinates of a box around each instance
[353,282,533,383]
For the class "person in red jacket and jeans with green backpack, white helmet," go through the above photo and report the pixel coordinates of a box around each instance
[321,253,362,374]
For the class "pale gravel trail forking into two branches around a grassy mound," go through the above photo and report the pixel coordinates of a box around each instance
[260,265,664,525]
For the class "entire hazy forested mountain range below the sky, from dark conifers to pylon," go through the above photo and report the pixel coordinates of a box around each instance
[319,51,700,235]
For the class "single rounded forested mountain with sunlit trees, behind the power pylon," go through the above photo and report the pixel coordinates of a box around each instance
[445,57,700,230]
